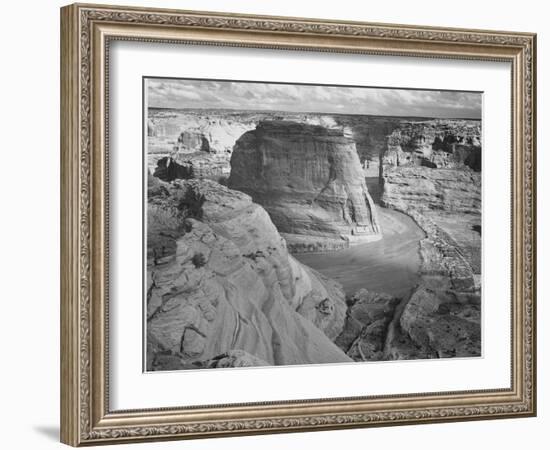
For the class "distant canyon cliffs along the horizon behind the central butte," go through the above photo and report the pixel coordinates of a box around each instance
[147,108,481,180]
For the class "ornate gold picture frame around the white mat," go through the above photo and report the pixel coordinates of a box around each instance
[61,4,536,446]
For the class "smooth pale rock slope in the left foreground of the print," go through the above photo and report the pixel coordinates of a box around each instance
[147,176,349,370]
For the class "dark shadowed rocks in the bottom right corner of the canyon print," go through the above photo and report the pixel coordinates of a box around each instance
[335,279,481,361]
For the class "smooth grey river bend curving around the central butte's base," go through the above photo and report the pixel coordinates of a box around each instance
[293,206,425,297]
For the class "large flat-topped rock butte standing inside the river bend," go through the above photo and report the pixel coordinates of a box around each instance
[228,121,380,251]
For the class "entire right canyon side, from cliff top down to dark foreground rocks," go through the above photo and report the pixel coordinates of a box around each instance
[335,120,481,361]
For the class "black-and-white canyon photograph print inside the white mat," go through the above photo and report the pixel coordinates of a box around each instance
[143,77,482,371]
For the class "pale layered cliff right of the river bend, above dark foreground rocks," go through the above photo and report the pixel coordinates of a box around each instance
[381,119,482,287]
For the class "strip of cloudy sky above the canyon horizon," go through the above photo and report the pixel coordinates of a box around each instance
[146,78,481,118]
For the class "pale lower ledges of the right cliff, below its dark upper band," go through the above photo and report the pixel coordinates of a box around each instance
[381,165,481,287]
